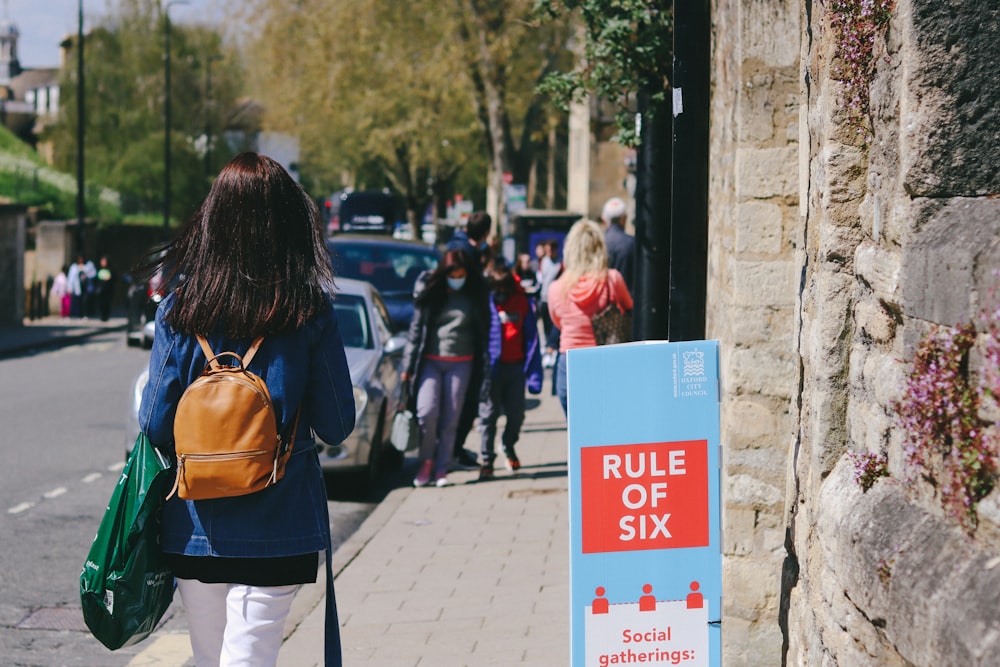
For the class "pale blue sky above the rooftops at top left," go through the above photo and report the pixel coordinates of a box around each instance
[7,0,218,67]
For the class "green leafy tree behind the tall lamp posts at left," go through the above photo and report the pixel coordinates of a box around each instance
[46,0,242,224]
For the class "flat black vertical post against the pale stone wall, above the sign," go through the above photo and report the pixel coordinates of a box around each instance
[669,0,712,341]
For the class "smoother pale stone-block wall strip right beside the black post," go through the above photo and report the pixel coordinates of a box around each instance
[707,0,801,665]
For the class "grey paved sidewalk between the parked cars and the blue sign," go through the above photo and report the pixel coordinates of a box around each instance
[278,384,569,667]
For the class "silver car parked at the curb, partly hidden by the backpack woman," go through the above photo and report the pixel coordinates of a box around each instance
[126,278,414,487]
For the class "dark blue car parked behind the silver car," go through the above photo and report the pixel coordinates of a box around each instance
[326,234,440,331]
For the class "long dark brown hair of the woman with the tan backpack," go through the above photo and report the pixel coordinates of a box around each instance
[150,153,333,338]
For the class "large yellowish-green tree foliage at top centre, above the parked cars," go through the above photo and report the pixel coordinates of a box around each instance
[238,0,568,232]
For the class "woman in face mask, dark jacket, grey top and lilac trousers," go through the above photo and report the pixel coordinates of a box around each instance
[402,250,490,487]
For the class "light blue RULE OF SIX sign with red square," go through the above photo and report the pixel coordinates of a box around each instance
[567,341,722,667]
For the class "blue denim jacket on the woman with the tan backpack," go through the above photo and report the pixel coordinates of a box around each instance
[139,295,355,558]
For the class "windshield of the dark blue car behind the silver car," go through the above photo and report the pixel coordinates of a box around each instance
[331,243,438,294]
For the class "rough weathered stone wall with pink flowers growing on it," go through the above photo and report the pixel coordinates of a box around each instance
[788,0,1000,665]
